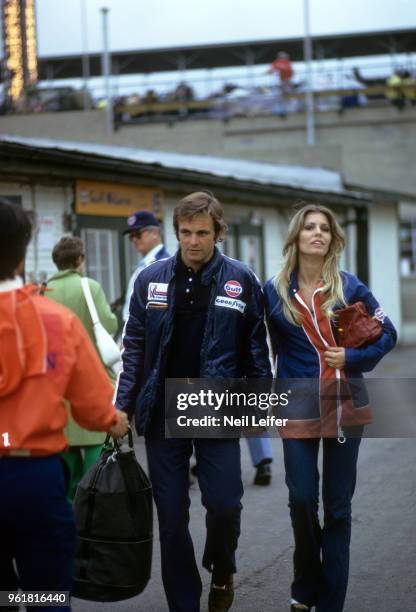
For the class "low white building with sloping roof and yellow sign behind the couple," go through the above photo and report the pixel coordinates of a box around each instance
[0,137,402,342]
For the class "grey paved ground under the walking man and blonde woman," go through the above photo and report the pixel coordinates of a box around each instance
[73,347,416,612]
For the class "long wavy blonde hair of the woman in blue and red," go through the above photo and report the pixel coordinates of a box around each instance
[273,204,346,325]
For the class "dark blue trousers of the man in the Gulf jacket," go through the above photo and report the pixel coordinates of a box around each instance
[146,435,243,612]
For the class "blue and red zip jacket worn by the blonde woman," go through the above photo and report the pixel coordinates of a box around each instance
[264,272,397,438]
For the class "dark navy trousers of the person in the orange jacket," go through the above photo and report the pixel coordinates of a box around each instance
[0,455,76,612]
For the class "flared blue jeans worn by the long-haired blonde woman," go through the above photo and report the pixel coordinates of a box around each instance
[283,438,361,612]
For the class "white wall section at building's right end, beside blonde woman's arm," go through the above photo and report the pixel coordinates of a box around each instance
[369,203,402,335]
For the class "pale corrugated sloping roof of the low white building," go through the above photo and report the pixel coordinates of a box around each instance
[0,135,362,197]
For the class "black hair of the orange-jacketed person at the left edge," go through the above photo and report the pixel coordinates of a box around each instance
[0,197,32,280]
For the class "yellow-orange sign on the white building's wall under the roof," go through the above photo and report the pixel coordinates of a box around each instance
[75,180,163,218]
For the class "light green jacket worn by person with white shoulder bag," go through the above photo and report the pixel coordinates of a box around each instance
[45,270,117,446]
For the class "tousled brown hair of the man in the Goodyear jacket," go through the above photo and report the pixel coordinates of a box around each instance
[173,191,227,238]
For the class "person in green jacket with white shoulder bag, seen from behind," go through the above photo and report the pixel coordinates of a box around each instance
[45,236,117,501]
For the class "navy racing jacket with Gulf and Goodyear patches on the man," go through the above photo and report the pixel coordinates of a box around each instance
[115,249,271,434]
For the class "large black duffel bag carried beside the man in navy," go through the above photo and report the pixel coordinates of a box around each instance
[72,429,153,601]
